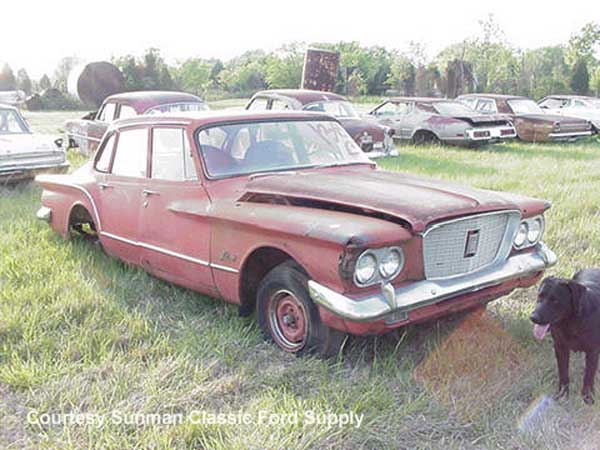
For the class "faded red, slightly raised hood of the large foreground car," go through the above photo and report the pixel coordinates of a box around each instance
[241,167,536,232]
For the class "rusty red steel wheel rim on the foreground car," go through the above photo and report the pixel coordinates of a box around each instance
[268,289,308,353]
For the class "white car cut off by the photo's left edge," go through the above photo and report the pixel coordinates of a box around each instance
[0,104,69,184]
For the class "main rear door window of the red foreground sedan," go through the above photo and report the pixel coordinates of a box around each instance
[112,128,148,178]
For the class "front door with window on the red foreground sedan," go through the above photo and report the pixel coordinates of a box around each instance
[139,125,214,293]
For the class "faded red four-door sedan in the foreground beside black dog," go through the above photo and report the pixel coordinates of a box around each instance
[37,111,556,355]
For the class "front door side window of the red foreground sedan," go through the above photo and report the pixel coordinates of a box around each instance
[152,128,198,181]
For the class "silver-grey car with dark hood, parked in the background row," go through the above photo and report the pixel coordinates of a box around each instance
[369,97,516,146]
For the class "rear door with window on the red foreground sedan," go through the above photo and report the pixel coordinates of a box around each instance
[96,126,149,264]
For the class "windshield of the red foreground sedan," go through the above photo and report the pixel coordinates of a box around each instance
[197,119,372,178]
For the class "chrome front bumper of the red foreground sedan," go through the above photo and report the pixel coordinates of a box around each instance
[308,243,557,322]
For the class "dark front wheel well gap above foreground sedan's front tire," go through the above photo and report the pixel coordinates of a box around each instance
[240,247,302,316]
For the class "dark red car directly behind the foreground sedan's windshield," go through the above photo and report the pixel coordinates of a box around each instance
[246,89,397,158]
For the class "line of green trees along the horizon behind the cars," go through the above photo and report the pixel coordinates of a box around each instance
[0,16,600,108]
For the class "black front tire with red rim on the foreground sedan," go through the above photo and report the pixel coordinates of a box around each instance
[256,261,345,358]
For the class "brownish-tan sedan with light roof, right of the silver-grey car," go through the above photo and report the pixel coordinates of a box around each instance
[456,94,592,142]
